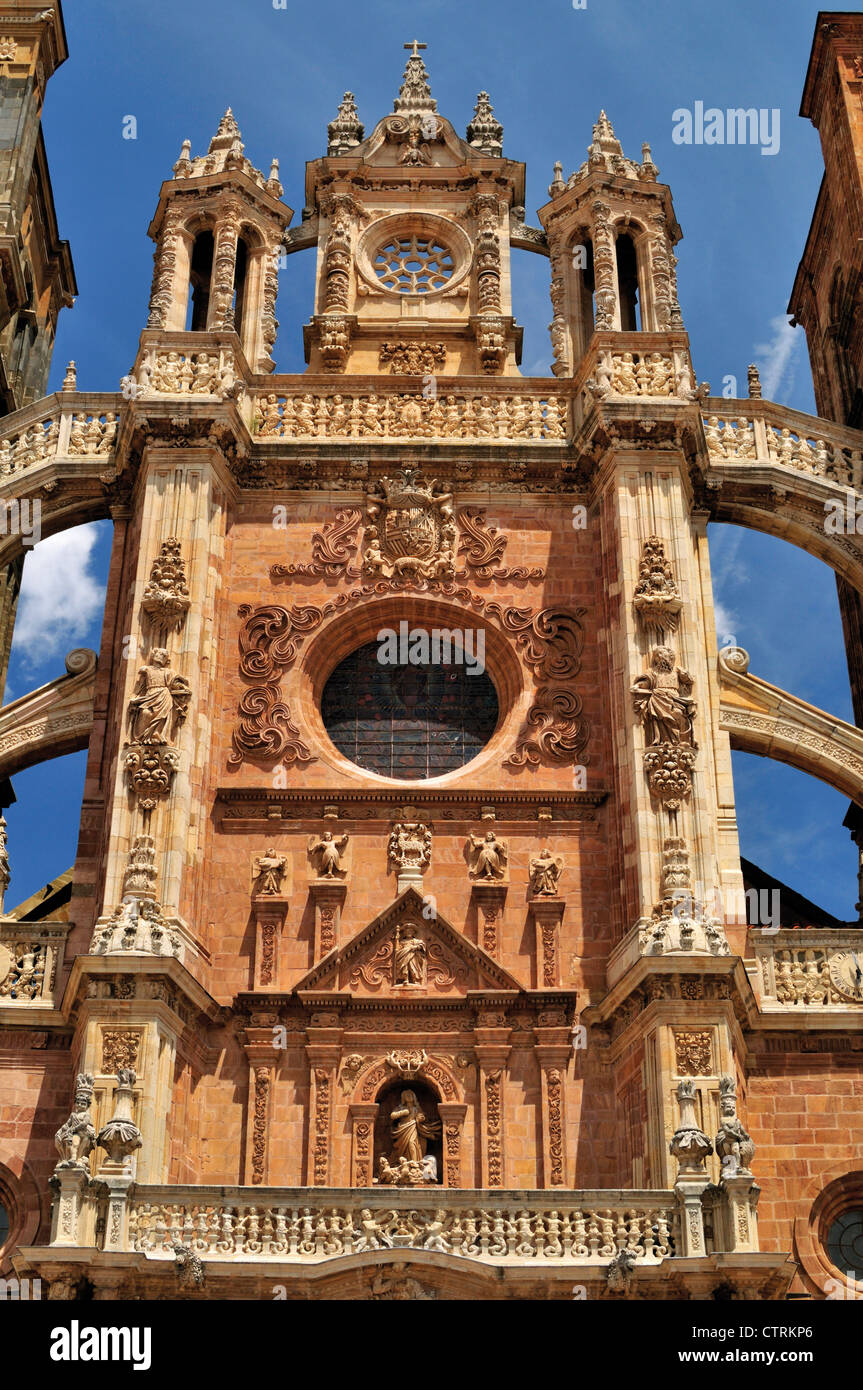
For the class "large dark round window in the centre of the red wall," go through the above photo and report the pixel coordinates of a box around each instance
[321,630,499,781]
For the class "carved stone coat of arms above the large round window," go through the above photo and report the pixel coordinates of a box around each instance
[364,468,456,580]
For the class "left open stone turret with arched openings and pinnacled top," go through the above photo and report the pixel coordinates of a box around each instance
[147,108,292,371]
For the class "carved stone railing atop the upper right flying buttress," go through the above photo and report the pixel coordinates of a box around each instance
[703,396,863,492]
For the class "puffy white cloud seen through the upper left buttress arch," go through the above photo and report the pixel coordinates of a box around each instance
[7,523,104,672]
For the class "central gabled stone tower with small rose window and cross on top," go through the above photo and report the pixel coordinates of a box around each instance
[296,40,524,377]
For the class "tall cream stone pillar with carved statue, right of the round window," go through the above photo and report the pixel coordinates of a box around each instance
[598,444,741,956]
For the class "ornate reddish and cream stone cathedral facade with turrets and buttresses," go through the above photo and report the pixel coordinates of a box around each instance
[0,6,863,1300]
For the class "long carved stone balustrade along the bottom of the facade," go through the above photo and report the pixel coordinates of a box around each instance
[122,1187,677,1265]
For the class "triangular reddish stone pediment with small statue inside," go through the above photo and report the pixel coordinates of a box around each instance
[296,888,525,1001]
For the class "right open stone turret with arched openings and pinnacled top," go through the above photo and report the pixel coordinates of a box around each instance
[539,111,682,377]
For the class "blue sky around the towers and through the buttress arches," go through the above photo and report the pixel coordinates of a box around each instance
[7,0,856,917]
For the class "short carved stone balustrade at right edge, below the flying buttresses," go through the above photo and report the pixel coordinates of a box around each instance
[749,927,863,1013]
